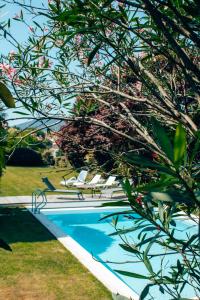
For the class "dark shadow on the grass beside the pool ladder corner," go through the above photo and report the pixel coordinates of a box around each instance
[0,207,55,247]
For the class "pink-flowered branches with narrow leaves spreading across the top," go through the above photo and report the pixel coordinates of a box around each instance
[2,0,199,159]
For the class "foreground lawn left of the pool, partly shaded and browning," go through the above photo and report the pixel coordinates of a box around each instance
[0,207,112,300]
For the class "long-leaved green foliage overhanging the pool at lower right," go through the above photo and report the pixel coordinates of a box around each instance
[102,125,200,299]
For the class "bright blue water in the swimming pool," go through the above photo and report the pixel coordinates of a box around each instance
[42,209,196,300]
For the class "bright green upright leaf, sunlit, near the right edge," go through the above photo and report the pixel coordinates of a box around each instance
[174,124,186,166]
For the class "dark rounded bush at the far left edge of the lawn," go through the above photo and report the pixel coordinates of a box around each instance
[7,148,44,166]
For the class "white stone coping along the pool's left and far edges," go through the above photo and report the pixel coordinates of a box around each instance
[27,206,139,300]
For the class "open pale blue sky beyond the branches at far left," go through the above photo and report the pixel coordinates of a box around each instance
[0,0,48,126]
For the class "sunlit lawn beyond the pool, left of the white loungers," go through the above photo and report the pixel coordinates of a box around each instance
[0,167,74,196]
